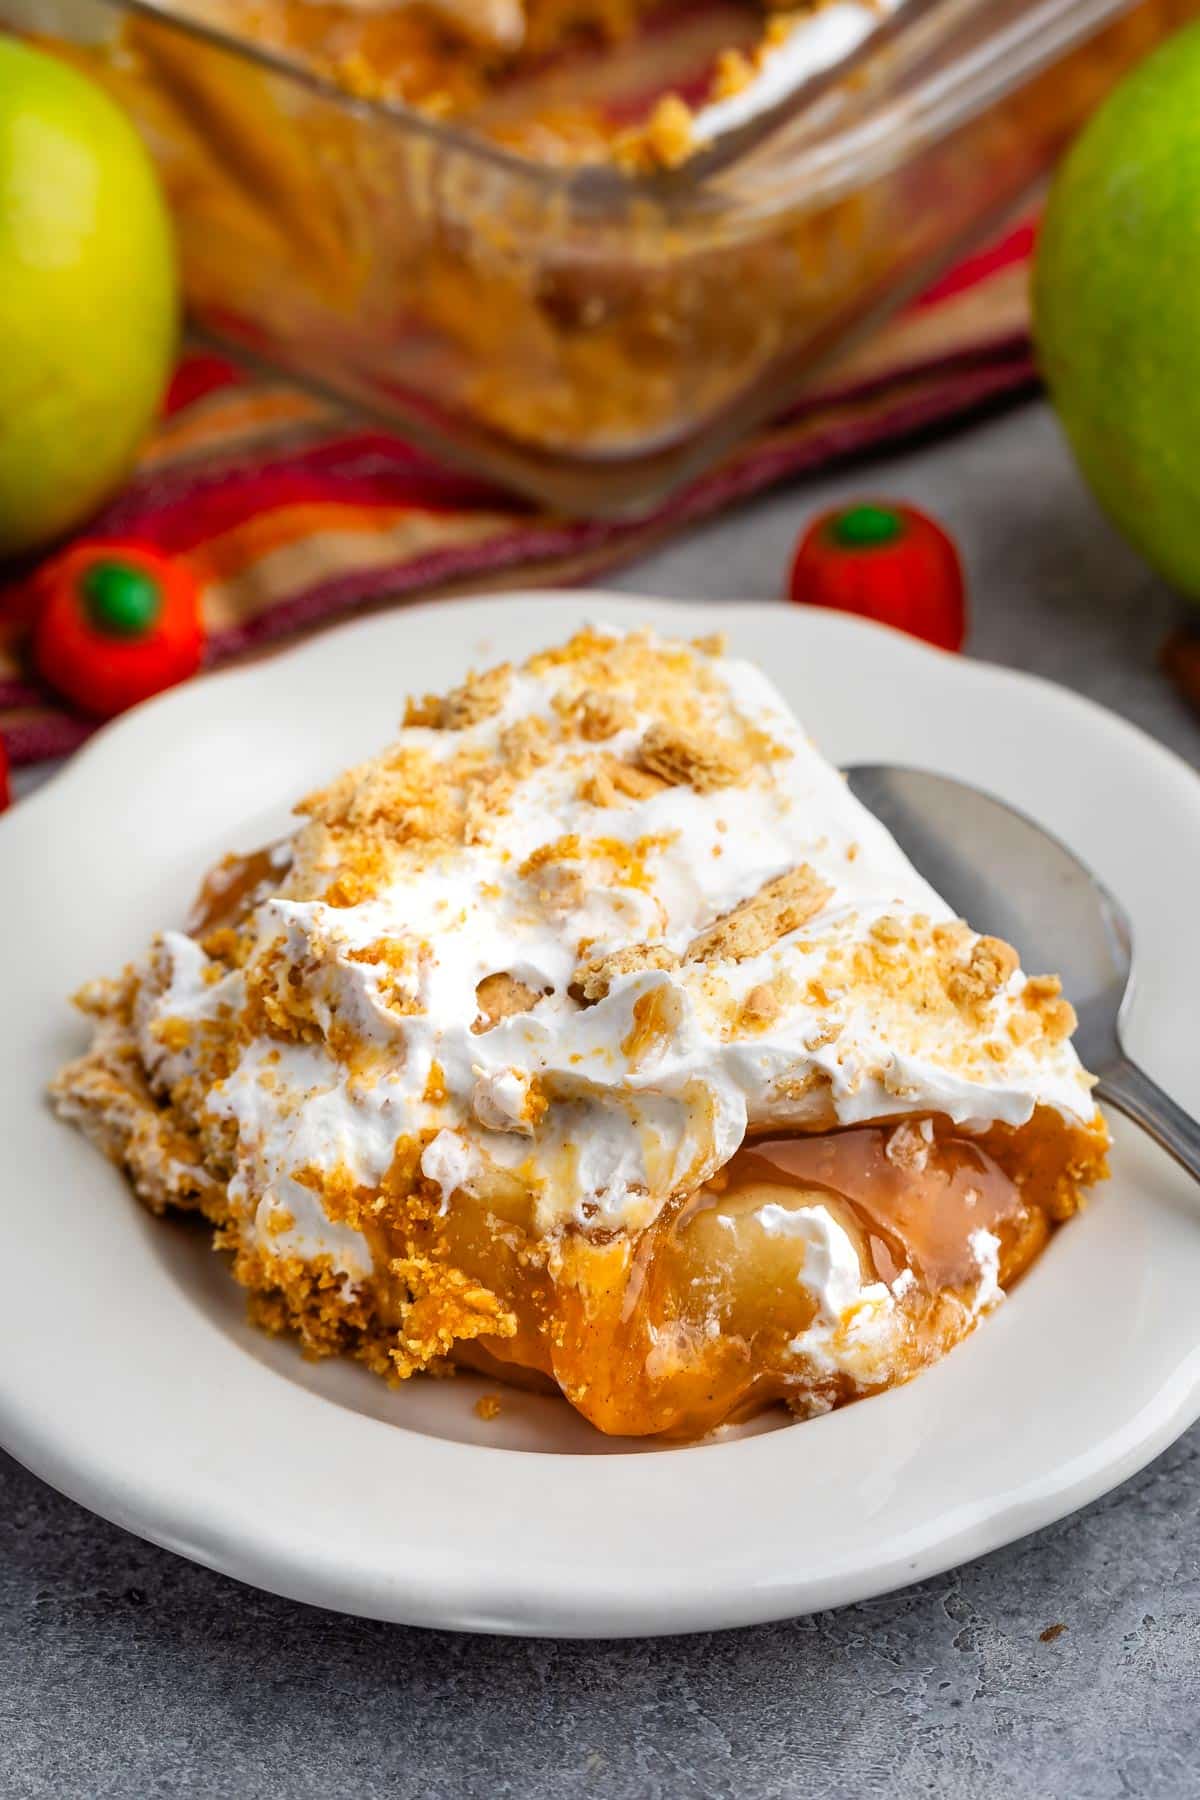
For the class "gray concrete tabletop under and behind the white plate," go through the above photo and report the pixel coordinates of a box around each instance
[0,405,1200,1800]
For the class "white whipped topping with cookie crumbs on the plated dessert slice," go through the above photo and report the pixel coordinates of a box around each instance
[137,630,1096,1321]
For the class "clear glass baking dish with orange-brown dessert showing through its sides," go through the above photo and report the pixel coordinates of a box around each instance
[9,0,1200,515]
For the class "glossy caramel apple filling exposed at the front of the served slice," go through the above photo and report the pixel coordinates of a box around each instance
[372,1125,1049,1438]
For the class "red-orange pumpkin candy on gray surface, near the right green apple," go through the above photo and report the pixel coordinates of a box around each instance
[788,502,966,650]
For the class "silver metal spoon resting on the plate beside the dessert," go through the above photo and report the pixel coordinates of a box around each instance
[846,763,1200,1181]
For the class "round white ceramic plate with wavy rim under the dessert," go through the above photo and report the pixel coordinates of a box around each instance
[0,594,1200,1636]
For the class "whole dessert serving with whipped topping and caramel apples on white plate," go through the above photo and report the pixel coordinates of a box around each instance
[54,630,1106,1436]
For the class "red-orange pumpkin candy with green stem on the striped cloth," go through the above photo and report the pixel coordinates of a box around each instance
[32,540,203,718]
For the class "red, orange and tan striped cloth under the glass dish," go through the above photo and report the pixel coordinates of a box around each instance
[0,225,1034,763]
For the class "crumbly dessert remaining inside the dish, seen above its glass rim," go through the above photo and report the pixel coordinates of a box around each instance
[180,0,852,166]
